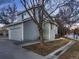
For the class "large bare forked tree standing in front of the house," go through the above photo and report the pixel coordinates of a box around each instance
[20,0,72,44]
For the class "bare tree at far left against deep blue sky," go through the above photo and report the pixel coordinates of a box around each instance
[0,4,17,24]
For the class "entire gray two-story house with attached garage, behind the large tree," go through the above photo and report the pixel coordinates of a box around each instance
[7,12,58,41]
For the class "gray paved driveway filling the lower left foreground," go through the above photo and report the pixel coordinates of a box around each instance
[0,40,44,59]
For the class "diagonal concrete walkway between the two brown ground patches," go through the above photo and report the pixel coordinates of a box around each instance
[45,41,75,59]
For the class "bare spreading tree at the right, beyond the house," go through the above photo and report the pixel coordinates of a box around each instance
[53,0,79,37]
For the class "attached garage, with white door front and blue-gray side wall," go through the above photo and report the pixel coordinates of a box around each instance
[7,20,39,41]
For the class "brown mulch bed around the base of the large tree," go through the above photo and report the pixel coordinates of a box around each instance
[23,40,69,56]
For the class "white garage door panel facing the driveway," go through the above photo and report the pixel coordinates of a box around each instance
[10,28,22,41]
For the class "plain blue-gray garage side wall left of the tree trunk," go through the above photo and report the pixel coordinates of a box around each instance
[24,20,39,41]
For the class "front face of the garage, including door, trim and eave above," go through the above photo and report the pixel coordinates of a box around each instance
[8,24,23,41]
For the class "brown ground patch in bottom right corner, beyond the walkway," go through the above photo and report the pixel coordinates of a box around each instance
[59,42,79,59]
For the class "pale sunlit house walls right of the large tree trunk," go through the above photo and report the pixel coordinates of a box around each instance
[44,23,57,40]
